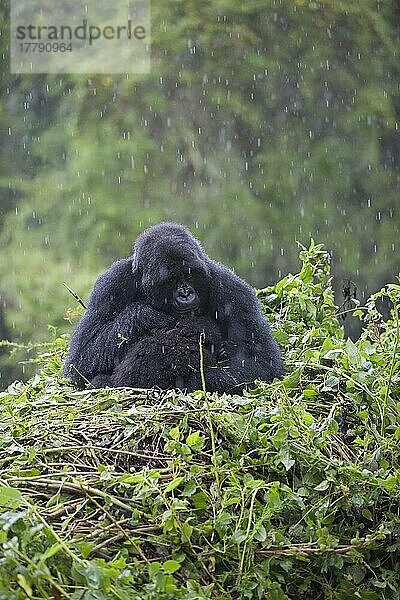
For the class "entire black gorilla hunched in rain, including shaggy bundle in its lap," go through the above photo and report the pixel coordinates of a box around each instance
[64,223,283,393]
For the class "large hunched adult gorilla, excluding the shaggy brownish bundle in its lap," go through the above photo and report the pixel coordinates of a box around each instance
[64,223,283,392]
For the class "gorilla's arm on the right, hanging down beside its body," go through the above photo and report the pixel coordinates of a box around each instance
[211,262,283,384]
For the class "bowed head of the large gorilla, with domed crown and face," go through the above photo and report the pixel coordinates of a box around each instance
[132,223,210,316]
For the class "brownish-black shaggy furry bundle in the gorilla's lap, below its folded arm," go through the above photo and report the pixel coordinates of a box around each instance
[99,318,234,393]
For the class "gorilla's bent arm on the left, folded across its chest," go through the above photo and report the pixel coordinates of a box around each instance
[64,258,174,387]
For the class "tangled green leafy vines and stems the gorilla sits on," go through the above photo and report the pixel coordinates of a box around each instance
[0,244,400,600]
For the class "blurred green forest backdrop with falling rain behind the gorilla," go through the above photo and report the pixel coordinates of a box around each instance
[0,0,400,386]
